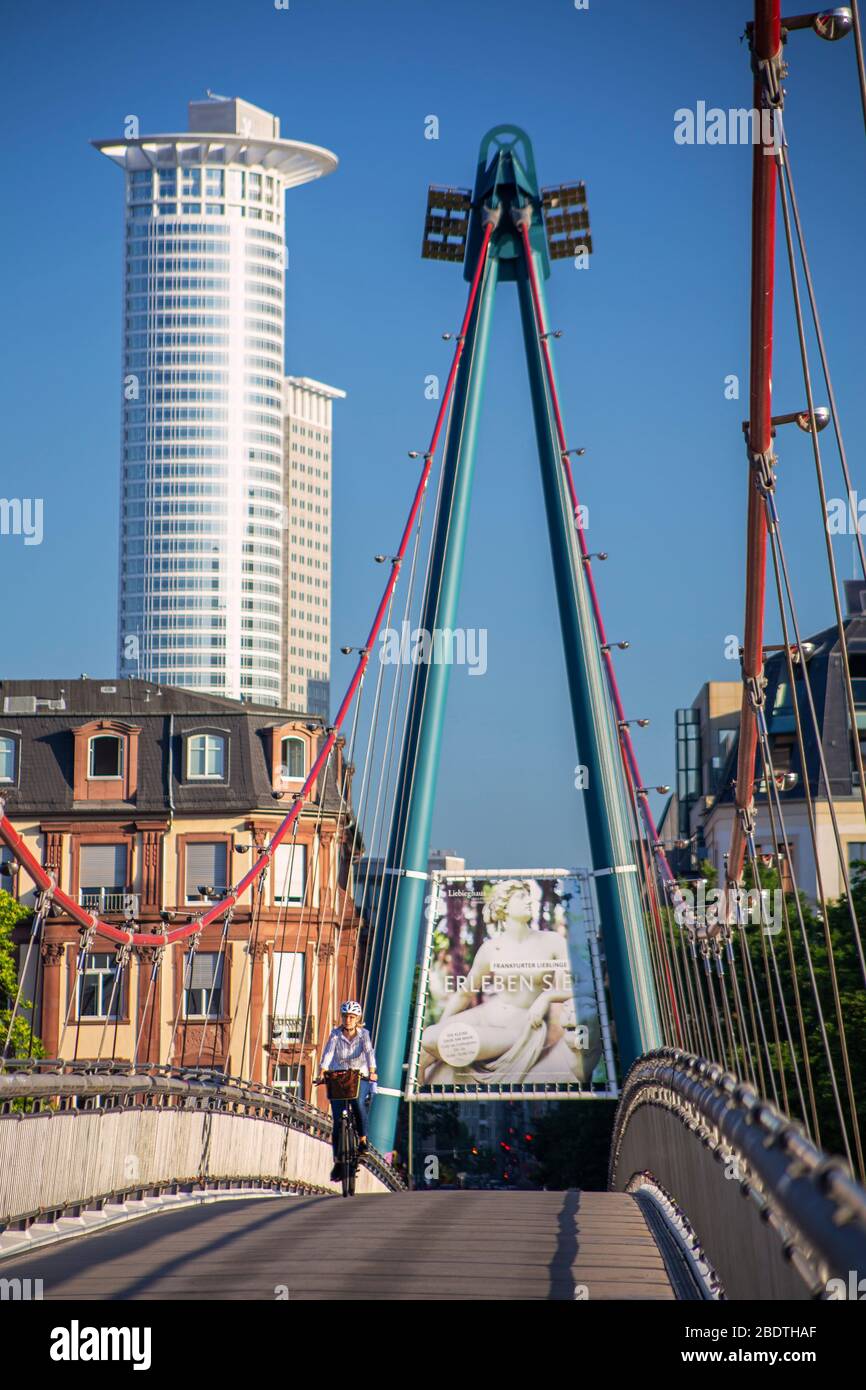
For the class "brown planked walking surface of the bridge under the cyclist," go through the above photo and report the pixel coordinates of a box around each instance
[0,1191,674,1301]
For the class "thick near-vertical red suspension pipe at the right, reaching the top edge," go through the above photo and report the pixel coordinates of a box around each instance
[727,0,781,883]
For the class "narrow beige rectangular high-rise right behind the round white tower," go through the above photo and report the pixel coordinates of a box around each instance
[284,377,346,720]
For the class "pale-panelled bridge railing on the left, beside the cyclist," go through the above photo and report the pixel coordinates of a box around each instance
[0,1062,403,1229]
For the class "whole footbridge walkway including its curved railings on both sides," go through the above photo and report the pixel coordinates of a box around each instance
[0,1049,866,1301]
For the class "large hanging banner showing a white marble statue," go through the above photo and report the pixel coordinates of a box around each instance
[407,870,617,1099]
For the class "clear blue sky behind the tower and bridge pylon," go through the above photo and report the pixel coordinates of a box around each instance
[0,0,866,866]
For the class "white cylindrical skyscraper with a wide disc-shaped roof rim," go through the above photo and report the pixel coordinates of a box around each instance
[95,97,336,705]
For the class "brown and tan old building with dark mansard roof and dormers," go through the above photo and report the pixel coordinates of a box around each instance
[0,677,360,1099]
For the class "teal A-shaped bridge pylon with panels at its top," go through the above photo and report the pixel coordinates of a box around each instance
[367,125,662,1151]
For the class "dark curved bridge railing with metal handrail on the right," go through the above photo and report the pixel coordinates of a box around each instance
[609,1048,866,1298]
